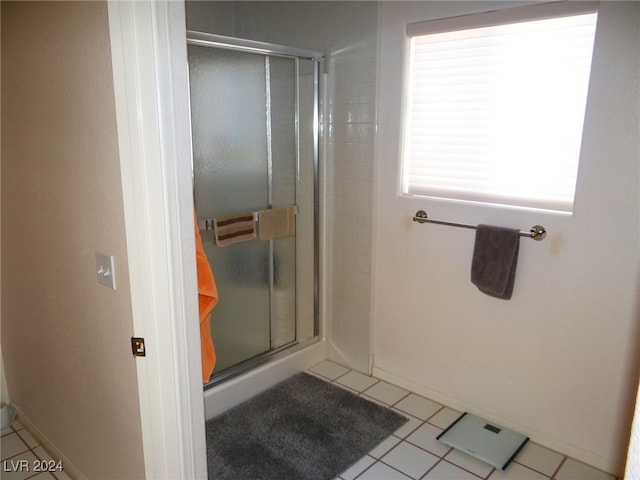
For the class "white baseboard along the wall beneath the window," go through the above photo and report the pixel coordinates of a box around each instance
[373,367,623,476]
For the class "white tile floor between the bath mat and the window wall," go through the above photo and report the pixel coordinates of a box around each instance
[309,361,615,480]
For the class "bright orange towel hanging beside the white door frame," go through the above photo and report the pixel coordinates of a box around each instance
[195,215,218,383]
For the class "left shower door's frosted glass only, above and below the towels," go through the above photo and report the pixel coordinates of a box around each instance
[189,45,271,374]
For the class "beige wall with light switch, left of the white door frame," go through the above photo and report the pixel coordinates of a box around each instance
[1,1,144,479]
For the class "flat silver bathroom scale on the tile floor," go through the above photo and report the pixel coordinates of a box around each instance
[436,412,529,471]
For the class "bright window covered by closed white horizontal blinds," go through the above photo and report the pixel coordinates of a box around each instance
[402,2,596,212]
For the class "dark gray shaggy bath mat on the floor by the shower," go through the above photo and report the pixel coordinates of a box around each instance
[206,373,407,480]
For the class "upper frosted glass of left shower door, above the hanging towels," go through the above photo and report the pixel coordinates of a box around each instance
[189,45,269,218]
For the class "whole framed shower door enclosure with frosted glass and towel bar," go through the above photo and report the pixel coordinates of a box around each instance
[187,31,322,388]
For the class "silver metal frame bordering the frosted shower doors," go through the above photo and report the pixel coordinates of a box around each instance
[187,30,325,390]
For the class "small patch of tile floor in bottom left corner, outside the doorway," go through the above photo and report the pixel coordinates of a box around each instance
[0,420,71,480]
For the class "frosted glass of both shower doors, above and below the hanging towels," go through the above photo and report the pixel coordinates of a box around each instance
[188,45,298,376]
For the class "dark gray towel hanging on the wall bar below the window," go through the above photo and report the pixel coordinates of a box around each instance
[471,225,520,300]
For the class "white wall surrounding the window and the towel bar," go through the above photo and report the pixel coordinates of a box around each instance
[373,2,640,473]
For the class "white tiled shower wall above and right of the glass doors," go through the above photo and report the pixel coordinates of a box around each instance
[187,1,378,372]
